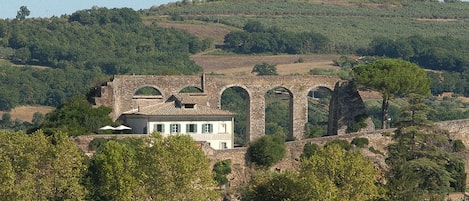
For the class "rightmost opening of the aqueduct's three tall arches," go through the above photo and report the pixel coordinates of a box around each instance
[305,87,332,138]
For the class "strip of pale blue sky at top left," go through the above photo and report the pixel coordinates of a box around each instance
[0,0,177,19]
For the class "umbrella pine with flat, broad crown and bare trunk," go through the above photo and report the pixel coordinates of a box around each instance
[353,59,430,128]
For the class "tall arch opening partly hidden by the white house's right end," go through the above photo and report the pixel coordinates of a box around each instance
[221,86,250,147]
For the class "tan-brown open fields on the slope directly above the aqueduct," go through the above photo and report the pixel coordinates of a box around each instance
[157,22,340,75]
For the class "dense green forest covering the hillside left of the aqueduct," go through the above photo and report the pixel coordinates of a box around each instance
[0,8,212,110]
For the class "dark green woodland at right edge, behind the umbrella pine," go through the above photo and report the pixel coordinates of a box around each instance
[364,36,469,96]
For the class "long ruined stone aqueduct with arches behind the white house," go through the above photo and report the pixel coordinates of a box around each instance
[95,74,364,143]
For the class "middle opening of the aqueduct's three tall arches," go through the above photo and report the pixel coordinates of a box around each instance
[265,87,294,141]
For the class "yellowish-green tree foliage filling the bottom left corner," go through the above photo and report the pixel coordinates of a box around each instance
[0,131,87,200]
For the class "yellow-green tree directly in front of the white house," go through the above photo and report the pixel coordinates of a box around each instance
[137,133,217,201]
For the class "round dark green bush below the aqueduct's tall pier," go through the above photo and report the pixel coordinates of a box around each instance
[248,135,286,168]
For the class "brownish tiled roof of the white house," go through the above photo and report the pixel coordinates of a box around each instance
[122,94,234,116]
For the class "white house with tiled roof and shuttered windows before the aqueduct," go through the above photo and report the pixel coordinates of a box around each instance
[120,95,234,149]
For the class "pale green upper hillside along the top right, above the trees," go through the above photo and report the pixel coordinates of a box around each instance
[145,1,469,50]
